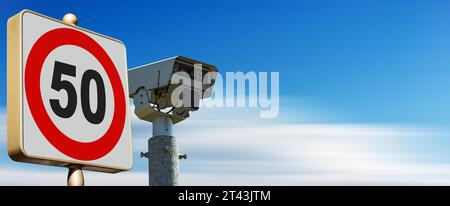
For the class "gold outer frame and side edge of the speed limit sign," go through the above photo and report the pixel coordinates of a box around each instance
[7,10,133,173]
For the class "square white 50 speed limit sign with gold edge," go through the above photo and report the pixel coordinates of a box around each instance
[7,10,132,172]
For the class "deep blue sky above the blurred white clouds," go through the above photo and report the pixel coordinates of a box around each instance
[0,0,450,124]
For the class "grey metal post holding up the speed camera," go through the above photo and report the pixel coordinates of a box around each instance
[148,115,179,186]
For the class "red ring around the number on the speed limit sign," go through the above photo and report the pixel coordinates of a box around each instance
[25,28,126,161]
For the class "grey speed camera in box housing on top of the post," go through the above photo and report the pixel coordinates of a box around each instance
[128,56,218,123]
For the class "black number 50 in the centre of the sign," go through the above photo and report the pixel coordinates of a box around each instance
[50,61,106,124]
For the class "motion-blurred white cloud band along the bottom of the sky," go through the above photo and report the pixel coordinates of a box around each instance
[4,105,450,185]
